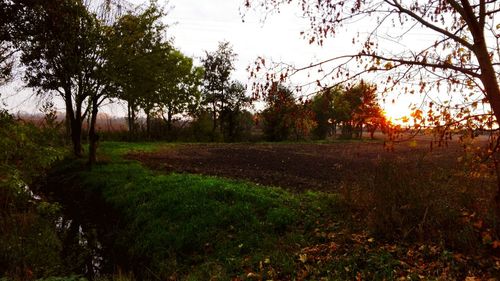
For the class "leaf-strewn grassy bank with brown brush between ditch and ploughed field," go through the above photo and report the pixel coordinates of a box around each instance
[52,142,499,280]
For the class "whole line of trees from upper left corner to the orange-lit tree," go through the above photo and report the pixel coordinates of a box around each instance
[0,0,385,163]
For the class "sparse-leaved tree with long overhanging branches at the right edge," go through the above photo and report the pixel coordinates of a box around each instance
[245,0,500,210]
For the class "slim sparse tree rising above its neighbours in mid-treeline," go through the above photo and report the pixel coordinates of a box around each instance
[202,42,236,138]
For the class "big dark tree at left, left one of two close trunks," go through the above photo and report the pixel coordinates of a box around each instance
[18,0,99,157]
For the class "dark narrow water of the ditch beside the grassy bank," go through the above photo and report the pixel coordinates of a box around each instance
[34,167,129,280]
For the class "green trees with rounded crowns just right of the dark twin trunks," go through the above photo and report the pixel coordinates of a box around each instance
[108,6,203,142]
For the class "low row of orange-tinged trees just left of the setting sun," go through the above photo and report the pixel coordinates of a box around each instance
[261,81,389,141]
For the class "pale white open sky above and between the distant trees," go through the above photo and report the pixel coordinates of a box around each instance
[1,0,425,119]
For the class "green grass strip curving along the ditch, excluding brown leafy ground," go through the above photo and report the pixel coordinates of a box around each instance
[75,142,348,280]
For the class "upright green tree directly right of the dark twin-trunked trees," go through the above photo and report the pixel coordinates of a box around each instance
[110,4,165,136]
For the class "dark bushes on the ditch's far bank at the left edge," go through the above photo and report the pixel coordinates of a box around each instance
[0,111,65,279]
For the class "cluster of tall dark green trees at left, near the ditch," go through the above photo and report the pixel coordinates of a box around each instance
[0,0,203,163]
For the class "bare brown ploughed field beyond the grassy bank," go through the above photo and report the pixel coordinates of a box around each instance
[128,140,461,191]
